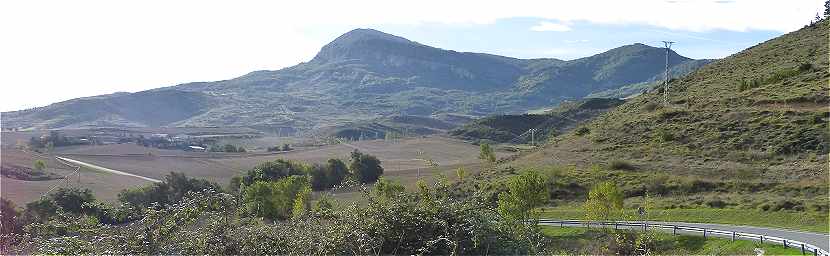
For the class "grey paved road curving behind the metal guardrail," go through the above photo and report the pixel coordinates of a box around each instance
[541,221,830,251]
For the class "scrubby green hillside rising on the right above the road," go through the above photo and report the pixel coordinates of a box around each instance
[480,20,830,218]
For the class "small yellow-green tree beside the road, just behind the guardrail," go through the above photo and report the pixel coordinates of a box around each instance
[585,181,623,221]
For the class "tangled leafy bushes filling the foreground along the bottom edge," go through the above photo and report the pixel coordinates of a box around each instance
[10,179,544,255]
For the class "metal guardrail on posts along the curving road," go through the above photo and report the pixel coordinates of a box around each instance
[539,219,830,256]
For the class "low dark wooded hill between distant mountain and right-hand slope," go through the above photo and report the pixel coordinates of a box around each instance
[450,98,623,143]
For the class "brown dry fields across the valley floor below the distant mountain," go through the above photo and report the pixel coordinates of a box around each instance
[2,136,508,204]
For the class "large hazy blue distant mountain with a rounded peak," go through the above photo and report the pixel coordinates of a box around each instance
[2,29,706,129]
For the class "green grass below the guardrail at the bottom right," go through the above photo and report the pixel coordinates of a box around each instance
[542,227,801,255]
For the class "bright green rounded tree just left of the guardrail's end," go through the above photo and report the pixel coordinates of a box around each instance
[498,171,550,220]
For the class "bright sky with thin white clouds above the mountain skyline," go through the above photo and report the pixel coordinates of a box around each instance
[0,0,824,111]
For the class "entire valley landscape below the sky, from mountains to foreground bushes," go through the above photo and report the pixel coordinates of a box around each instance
[0,5,830,255]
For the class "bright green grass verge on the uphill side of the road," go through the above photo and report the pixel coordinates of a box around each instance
[542,207,830,233]
